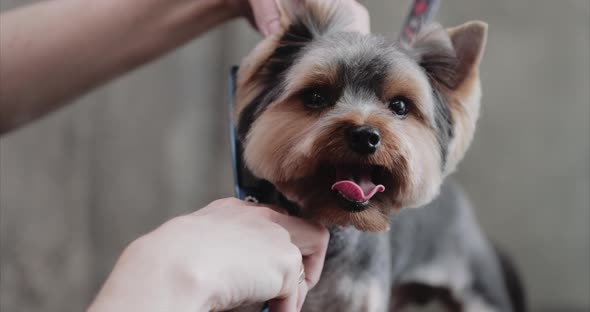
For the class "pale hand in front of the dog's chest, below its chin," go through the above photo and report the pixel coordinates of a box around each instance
[89,199,329,312]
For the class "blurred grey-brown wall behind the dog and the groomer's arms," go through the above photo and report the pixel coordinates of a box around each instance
[0,0,590,312]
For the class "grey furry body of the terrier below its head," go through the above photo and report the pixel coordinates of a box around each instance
[303,182,513,312]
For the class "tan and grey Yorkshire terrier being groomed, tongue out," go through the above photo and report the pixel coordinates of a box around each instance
[234,0,524,312]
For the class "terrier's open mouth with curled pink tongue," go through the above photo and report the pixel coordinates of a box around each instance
[330,164,392,212]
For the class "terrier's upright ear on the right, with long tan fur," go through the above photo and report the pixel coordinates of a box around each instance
[412,21,487,174]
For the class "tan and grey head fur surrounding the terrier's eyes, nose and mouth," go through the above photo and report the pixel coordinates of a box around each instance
[236,0,487,231]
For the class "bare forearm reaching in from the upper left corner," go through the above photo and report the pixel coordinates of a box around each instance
[0,0,237,133]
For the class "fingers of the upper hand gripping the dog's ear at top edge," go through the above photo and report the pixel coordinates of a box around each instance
[226,0,369,37]
